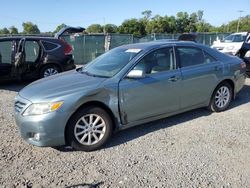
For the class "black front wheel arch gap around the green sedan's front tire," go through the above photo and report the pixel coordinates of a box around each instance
[64,101,118,144]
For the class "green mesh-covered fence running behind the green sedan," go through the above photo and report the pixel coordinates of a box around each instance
[0,33,229,64]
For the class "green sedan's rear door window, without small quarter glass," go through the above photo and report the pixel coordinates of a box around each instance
[177,47,206,67]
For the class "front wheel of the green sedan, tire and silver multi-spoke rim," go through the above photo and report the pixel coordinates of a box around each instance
[66,106,113,151]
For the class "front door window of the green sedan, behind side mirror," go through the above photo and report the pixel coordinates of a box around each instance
[134,48,175,74]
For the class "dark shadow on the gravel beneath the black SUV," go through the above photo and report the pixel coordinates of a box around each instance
[0,81,31,92]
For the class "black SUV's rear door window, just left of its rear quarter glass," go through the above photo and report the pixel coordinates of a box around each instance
[25,41,40,62]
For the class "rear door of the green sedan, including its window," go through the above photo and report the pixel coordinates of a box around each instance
[176,46,223,109]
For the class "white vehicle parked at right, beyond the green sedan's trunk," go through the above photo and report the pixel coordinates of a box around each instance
[211,32,250,55]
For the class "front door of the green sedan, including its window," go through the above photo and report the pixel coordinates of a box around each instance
[119,47,181,124]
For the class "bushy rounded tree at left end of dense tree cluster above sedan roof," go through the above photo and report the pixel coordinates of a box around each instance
[118,18,146,37]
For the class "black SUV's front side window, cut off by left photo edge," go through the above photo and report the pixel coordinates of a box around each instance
[0,41,12,64]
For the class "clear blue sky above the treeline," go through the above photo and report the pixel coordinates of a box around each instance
[0,0,250,32]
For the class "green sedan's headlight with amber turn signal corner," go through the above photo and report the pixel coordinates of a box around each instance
[23,101,63,116]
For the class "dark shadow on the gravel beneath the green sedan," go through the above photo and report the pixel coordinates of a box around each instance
[54,82,250,152]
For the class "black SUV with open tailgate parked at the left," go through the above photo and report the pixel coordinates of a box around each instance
[0,27,84,80]
